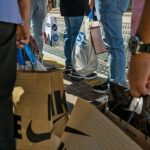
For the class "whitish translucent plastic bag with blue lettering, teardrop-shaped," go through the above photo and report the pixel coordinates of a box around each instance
[72,17,98,76]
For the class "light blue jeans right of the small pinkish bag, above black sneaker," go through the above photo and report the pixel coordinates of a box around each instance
[95,0,130,85]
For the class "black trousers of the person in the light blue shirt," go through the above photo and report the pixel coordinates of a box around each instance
[0,22,17,150]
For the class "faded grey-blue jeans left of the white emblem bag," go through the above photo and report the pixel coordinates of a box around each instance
[30,0,47,57]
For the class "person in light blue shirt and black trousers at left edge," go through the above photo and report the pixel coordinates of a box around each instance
[0,0,30,150]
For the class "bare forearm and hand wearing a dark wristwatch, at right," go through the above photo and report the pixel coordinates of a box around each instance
[128,0,150,97]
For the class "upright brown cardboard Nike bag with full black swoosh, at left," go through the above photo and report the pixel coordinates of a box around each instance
[13,71,68,150]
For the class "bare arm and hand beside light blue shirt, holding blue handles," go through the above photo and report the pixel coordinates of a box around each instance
[16,0,30,48]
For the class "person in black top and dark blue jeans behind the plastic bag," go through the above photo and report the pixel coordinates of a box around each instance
[60,0,92,78]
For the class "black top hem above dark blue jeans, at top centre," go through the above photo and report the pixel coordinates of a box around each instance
[60,0,89,17]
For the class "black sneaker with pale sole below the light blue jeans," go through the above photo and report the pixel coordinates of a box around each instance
[93,80,109,94]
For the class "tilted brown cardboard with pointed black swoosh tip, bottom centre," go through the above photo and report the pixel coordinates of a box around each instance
[59,99,141,150]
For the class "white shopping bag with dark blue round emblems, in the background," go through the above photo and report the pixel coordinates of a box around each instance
[43,15,60,47]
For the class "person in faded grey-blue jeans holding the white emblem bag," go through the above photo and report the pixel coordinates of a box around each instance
[30,0,55,70]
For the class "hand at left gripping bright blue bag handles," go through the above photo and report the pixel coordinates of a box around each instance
[16,24,30,48]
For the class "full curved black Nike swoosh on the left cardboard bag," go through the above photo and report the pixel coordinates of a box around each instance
[26,120,53,143]
